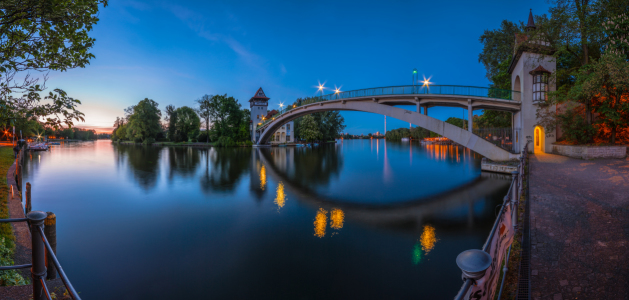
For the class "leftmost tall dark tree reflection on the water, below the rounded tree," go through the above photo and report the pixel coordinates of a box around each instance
[114,145,161,190]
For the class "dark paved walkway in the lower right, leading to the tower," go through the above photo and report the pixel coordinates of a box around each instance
[530,154,629,300]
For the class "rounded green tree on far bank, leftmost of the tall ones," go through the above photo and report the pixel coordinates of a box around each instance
[127,98,162,142]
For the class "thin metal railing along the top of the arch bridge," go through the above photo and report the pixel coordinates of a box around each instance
[256,85,520,129]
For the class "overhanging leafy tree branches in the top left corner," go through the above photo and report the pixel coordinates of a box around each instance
[0,0,107,127]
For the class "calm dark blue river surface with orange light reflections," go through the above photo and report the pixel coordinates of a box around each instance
[24,140,509,299]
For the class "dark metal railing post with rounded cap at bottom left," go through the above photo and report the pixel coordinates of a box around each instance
[26,210,46,300]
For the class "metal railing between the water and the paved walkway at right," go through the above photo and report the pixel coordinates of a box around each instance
[454,143,530,300]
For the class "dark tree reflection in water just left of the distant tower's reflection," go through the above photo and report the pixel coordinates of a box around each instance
[201,147,251,193]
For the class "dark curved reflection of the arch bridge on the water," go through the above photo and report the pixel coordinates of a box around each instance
[251,148,509,231]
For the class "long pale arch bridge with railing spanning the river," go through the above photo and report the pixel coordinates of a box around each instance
[254,85,522,161]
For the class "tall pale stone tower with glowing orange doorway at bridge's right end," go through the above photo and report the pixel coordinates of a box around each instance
[509,11,557,153]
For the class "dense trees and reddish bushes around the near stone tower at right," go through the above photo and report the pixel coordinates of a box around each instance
[479,0,629,144]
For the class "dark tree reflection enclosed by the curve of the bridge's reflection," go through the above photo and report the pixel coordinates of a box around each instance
[261,145,343,191]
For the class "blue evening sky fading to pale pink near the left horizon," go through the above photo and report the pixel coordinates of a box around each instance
[47,0,549,134]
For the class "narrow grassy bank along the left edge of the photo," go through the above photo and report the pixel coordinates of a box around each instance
[0,147,26,286]
